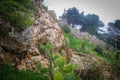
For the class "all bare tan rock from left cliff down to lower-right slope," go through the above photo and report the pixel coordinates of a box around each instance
[0,1,117,80]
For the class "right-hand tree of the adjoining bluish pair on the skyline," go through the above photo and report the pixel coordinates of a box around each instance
[81,14,104,35]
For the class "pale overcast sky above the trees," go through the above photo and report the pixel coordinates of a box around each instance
[44,0,120,23]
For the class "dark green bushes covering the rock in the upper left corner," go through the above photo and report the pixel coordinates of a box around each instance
[0,0,35,32]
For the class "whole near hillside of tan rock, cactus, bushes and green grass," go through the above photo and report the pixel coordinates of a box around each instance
[0,0,119,80]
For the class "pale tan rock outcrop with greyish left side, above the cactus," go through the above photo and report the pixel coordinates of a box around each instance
[0,5,64,53]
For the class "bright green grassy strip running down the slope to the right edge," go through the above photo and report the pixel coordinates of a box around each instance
[65,33,120,77]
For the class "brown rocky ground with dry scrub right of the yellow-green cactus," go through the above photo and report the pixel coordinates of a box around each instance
[71,52,119,80]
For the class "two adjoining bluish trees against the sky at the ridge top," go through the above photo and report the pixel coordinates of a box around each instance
[62,7,104,35]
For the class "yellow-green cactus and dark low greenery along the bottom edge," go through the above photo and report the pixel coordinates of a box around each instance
[0,42,81,80]
